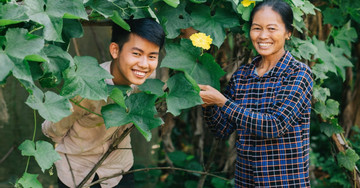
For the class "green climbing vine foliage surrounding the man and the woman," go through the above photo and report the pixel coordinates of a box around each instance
[0,0,360,187]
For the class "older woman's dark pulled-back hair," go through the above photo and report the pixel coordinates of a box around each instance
[250,0,294,32]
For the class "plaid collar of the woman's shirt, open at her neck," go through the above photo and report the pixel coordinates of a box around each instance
[247,51,293,77]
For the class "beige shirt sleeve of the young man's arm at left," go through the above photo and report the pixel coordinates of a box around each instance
[41,96,88,143]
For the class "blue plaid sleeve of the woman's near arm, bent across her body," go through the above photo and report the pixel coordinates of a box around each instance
[219,68,313,138]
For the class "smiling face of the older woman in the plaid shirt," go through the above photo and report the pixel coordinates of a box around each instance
[250,7,291,60]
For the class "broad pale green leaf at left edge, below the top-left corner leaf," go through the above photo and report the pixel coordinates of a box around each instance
[5,28,44,59]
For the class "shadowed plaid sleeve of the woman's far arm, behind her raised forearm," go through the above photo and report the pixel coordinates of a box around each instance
[203,75,235,138]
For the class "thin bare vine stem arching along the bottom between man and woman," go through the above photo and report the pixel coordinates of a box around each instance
[84,166,230,187]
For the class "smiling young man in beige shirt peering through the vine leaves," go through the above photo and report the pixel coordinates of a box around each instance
[42,18,165,187]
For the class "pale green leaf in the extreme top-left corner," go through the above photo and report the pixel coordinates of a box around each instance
[0,2,29,26]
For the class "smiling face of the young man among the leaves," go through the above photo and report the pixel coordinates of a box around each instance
[110,34,160,85]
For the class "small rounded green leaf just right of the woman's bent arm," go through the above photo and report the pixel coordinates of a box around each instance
[314,99,339,119]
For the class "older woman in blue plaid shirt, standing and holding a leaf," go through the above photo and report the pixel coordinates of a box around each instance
[200,0,313,187]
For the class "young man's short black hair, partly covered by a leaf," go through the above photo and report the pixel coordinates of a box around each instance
[111,18,165,50]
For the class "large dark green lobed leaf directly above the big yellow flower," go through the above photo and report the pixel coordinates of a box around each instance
[191,5,240,47]
